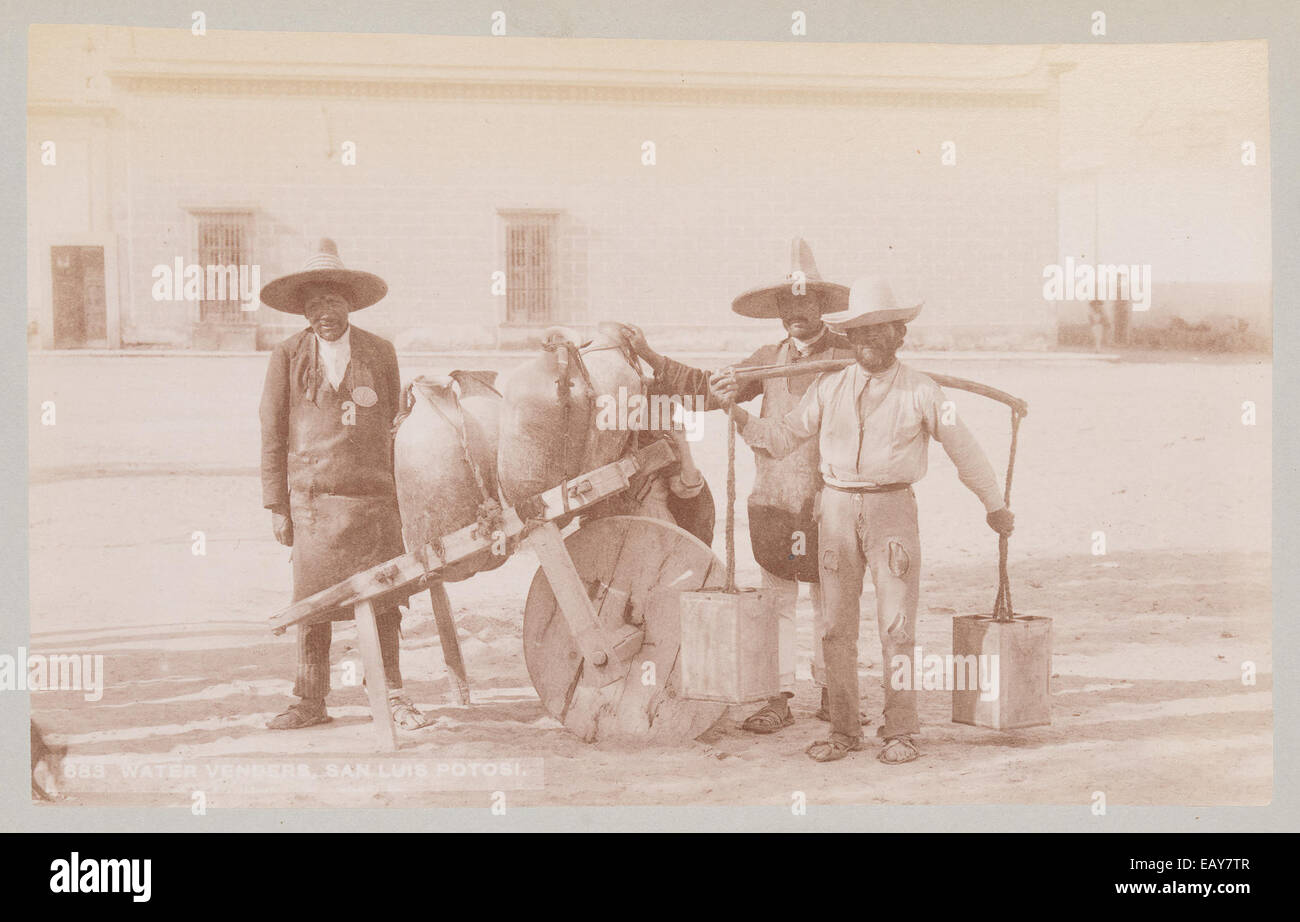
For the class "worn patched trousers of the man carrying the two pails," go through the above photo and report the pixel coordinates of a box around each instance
[818,486,920,743]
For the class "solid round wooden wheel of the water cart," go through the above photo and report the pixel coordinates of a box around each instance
[524,515,727,743]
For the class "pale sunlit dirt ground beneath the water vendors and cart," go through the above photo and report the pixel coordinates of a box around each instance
[30,354,1273,806]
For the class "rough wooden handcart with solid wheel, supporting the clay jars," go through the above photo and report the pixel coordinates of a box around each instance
[270,441,725,752]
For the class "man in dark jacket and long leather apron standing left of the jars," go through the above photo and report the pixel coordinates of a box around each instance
[261,239,425,730]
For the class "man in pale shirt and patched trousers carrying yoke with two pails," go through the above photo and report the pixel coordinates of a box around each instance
[711,278,1015,763]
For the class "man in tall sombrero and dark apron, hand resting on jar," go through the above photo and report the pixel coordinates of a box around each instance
[628,237,854,733]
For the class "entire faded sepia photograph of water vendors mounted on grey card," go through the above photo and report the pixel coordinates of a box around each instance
[22,14,1275,821]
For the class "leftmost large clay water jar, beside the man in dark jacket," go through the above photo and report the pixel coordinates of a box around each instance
[393,372,506,583]
